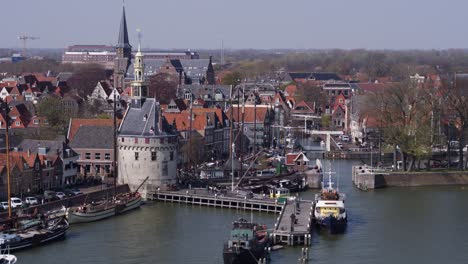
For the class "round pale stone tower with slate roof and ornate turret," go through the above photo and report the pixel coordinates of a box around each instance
[117,45,178,197]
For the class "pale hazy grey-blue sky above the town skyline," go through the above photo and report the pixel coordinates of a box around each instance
[0,0,468,49]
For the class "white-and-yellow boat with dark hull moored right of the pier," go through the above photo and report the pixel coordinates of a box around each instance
[314,164,348,234]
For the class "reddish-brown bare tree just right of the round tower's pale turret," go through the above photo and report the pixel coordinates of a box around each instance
[148,72,179,104]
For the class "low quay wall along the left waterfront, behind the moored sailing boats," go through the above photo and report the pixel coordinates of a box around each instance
[0,184,130,219]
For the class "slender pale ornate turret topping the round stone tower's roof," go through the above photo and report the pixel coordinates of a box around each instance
[131,44,148,108]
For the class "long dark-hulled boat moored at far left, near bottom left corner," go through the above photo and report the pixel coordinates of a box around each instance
[0,217,69,251]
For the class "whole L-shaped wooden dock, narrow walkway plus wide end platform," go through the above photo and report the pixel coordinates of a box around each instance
[147,189,314,246]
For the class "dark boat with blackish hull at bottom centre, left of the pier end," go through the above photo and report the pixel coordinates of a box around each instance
[223,218,270,264]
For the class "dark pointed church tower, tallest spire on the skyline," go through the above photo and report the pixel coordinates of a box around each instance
[114,6,132,89]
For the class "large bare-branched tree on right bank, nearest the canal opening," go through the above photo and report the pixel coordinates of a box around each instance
[367,80,432,170]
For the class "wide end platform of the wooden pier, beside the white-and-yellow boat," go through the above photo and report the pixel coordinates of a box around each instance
[272,200,314,246]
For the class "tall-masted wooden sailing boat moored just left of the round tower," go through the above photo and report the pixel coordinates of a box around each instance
[67,93,143,224]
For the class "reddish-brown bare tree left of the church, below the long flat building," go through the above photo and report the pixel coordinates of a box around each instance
[67,64,107,98]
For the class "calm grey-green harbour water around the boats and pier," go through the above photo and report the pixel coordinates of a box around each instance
[16,161,468,264]
